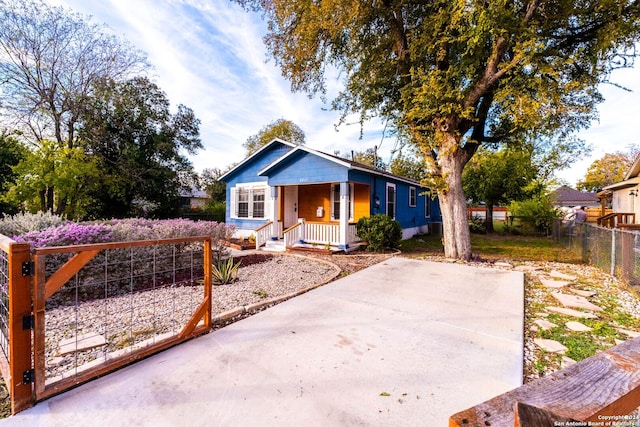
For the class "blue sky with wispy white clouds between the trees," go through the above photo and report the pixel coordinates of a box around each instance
[49,0,640,186]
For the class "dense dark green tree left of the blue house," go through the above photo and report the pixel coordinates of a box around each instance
[79,77,202,217]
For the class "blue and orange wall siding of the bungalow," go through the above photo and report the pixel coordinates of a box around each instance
[223,141,442,238]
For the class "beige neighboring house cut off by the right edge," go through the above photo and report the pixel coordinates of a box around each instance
[599,156,640,227]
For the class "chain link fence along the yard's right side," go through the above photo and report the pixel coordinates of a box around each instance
[553,220,640,285]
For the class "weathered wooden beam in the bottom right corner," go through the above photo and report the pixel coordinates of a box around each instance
[449,337,640,427]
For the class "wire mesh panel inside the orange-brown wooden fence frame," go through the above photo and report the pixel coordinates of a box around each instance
[34,241,210,392]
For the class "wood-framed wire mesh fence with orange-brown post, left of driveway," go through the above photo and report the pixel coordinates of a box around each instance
[0,236,212,413]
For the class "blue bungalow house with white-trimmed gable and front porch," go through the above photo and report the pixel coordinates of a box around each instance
[220,139,442,250]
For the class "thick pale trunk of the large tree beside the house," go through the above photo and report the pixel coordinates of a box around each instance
[438,134,471,260]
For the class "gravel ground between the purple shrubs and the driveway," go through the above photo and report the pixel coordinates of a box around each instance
[45,255,350,379]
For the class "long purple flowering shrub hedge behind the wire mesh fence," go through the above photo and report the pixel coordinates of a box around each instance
[14,218,233,307]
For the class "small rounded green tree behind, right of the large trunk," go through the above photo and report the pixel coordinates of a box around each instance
[462,147,541,232]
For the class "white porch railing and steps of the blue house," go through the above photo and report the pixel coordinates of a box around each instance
[254,218,362,252]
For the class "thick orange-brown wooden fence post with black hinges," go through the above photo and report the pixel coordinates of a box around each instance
[7,243,34,414]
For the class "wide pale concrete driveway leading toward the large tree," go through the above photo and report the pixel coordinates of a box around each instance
[0,257,524,427]
